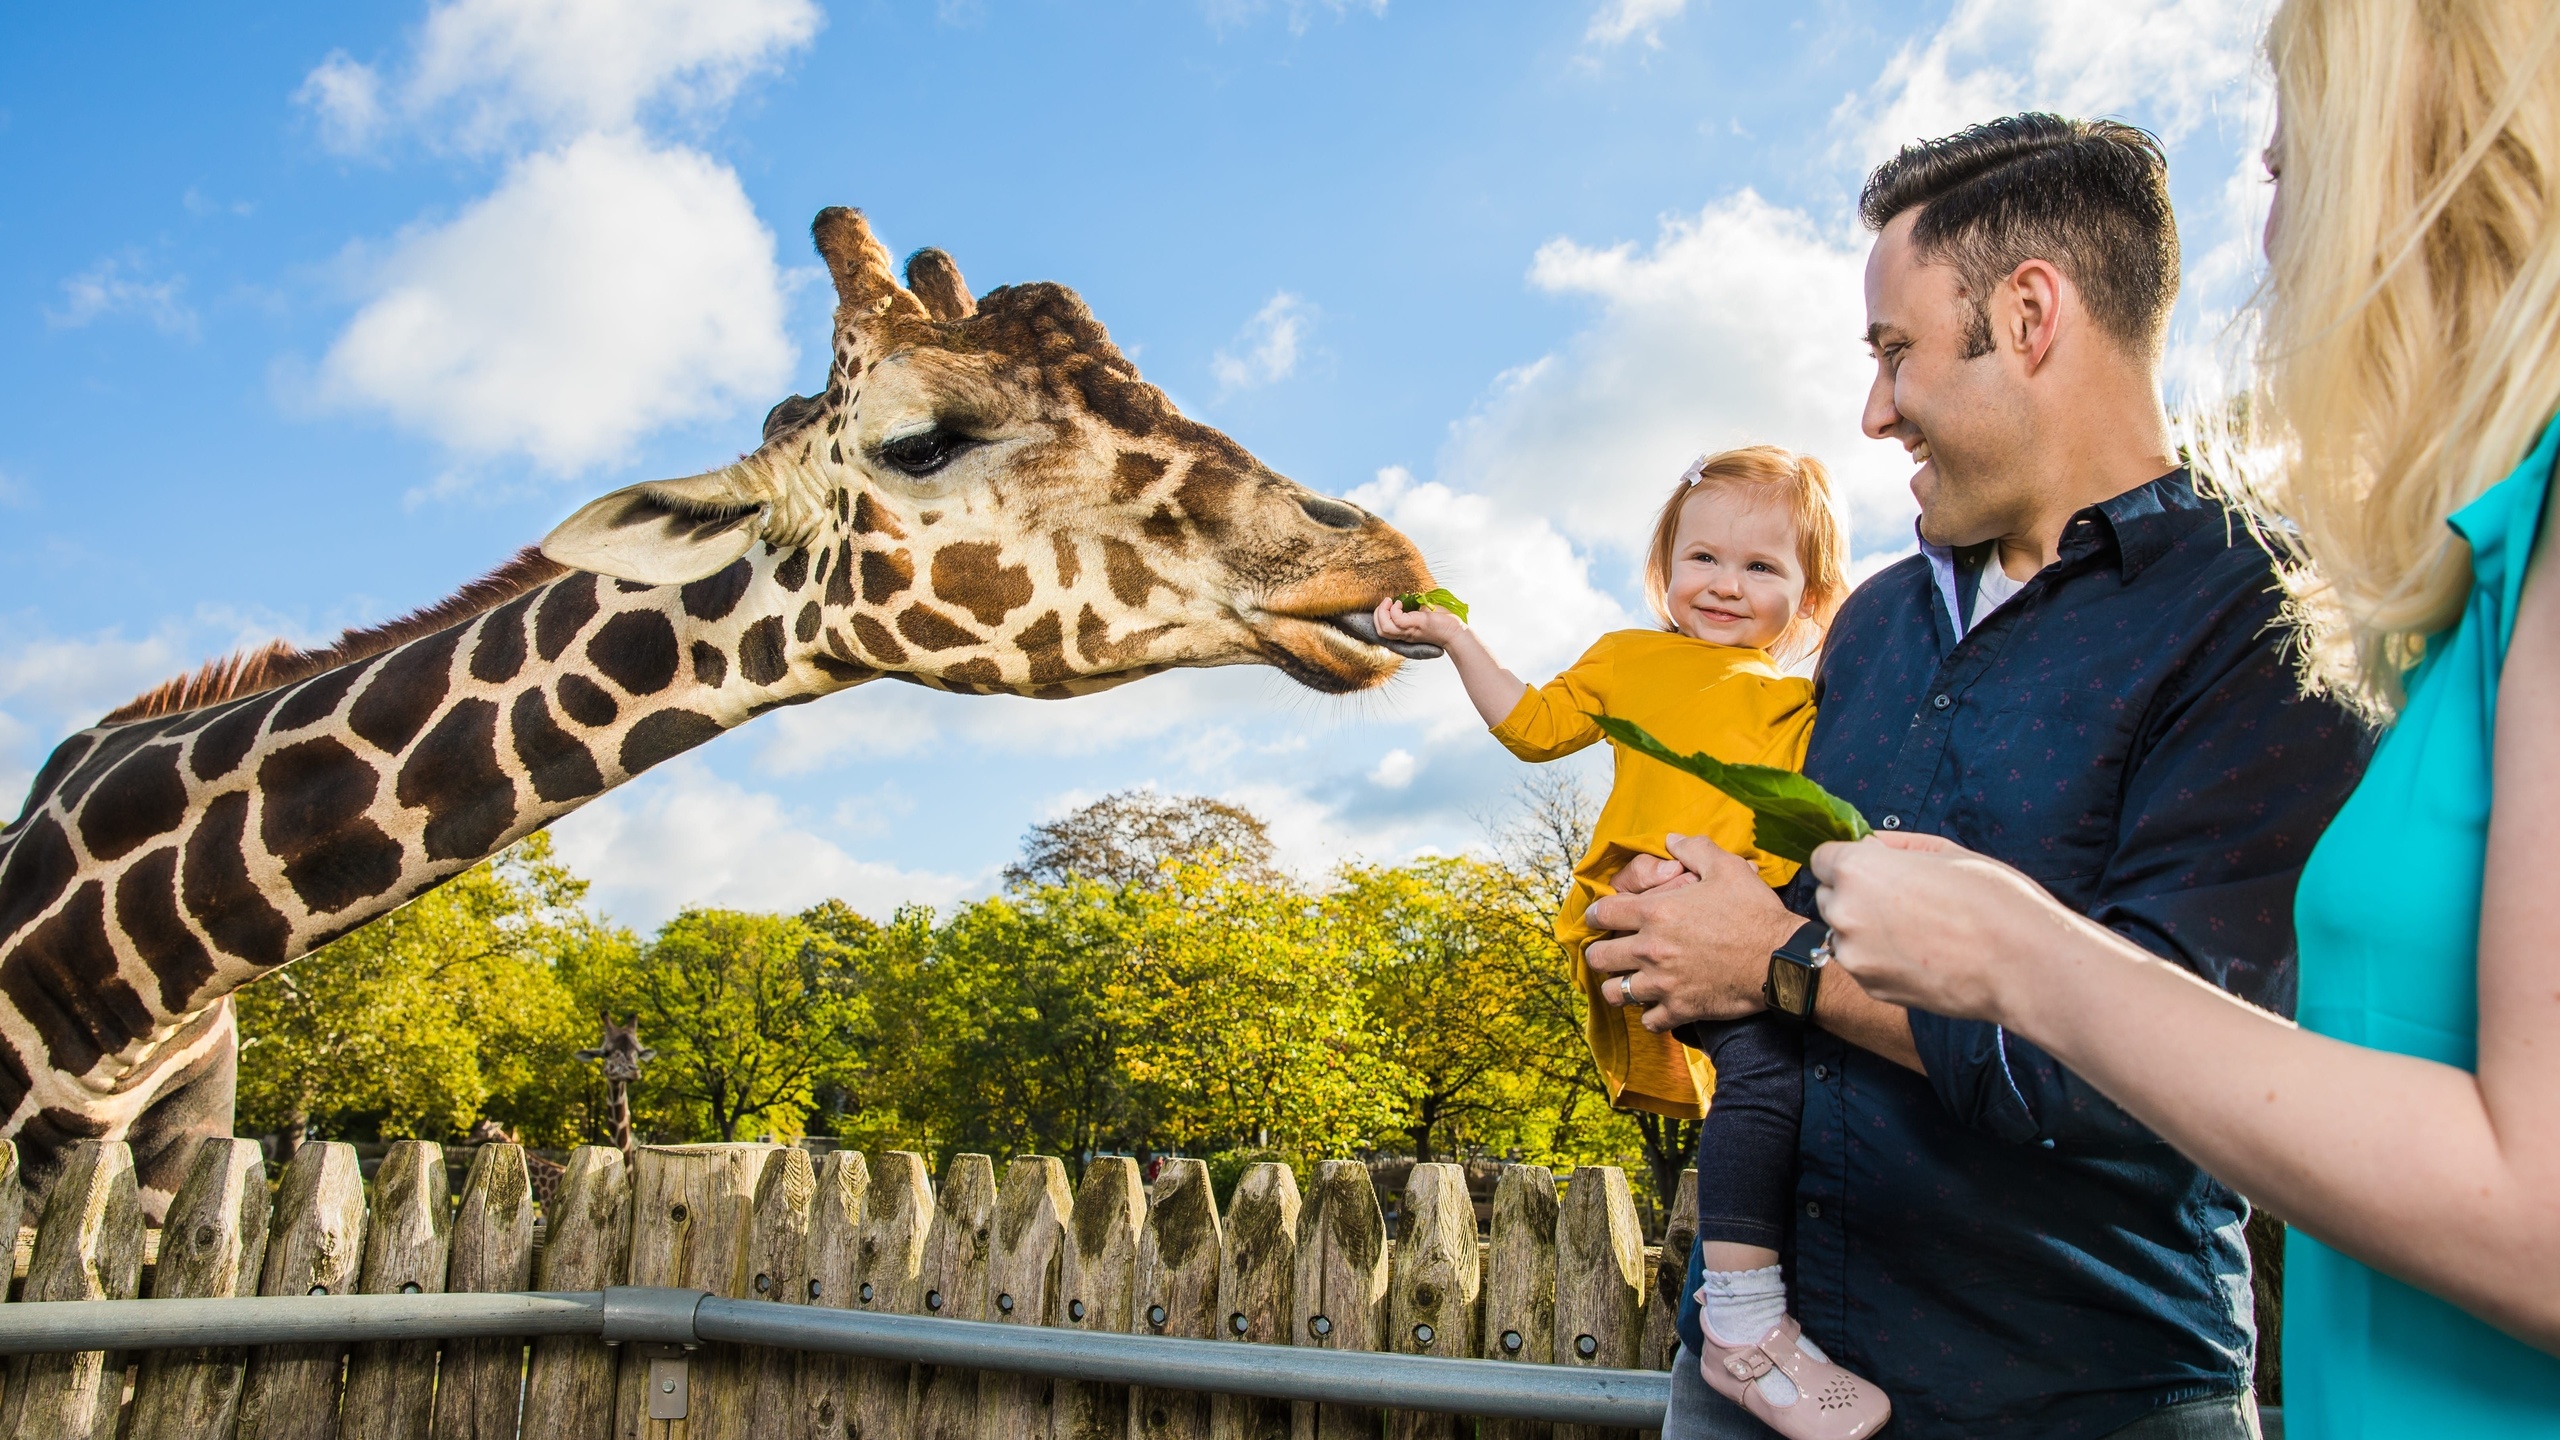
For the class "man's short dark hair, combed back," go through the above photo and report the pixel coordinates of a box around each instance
[1859,113,2179,359]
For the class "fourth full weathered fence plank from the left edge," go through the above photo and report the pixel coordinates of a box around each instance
[343,1140,453,1440]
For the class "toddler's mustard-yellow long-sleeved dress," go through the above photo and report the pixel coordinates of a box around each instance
[1492,630,1812,1120]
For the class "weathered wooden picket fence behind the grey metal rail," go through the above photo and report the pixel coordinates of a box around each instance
[0,1140,1697,1440]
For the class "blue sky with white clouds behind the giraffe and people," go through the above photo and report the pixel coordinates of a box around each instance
[0,0,2266,922]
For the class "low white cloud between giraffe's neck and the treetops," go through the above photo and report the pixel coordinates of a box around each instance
[550,758,993,928]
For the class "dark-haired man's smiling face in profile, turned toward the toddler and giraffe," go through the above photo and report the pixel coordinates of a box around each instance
[1864,208,2035,546]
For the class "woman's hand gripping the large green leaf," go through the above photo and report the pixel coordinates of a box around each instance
[1812,830,2086,1025]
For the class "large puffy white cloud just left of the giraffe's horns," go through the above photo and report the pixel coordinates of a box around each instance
[317,133,796,474]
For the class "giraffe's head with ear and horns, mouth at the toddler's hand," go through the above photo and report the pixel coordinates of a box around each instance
[543,210,1436,697]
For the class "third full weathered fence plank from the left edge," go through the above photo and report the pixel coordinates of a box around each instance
[241,1140,364,1440]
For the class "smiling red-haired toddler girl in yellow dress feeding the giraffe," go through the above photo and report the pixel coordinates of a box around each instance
[1377,446,1892,1440]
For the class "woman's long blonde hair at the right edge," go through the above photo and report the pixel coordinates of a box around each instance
[2222,0,2560,717]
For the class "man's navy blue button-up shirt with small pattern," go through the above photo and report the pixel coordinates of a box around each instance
[1682,471,2371,1440]
